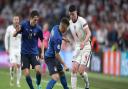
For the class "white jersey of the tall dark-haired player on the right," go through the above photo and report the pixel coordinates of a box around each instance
[69,16,90,46]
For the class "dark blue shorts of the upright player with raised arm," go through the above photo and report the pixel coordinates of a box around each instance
[21,54,40,70]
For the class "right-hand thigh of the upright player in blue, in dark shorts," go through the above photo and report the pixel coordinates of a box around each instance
[30,55,40,70]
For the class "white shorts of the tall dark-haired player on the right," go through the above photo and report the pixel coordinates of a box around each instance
[73,46,91,67]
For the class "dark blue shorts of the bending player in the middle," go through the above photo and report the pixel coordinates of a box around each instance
[45,57,63,75]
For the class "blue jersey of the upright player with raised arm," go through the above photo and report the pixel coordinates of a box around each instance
[21,20,43,55]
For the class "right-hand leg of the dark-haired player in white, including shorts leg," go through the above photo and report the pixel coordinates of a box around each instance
[79,51,91,89]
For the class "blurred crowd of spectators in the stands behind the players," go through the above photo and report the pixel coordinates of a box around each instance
[0,0,128,52]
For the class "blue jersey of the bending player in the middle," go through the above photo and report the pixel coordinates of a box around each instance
[45,25,62,58]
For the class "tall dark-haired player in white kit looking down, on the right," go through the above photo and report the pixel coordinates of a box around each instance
[69,5,91,89]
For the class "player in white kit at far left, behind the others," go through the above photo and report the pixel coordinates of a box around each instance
[5,15,21,87]
